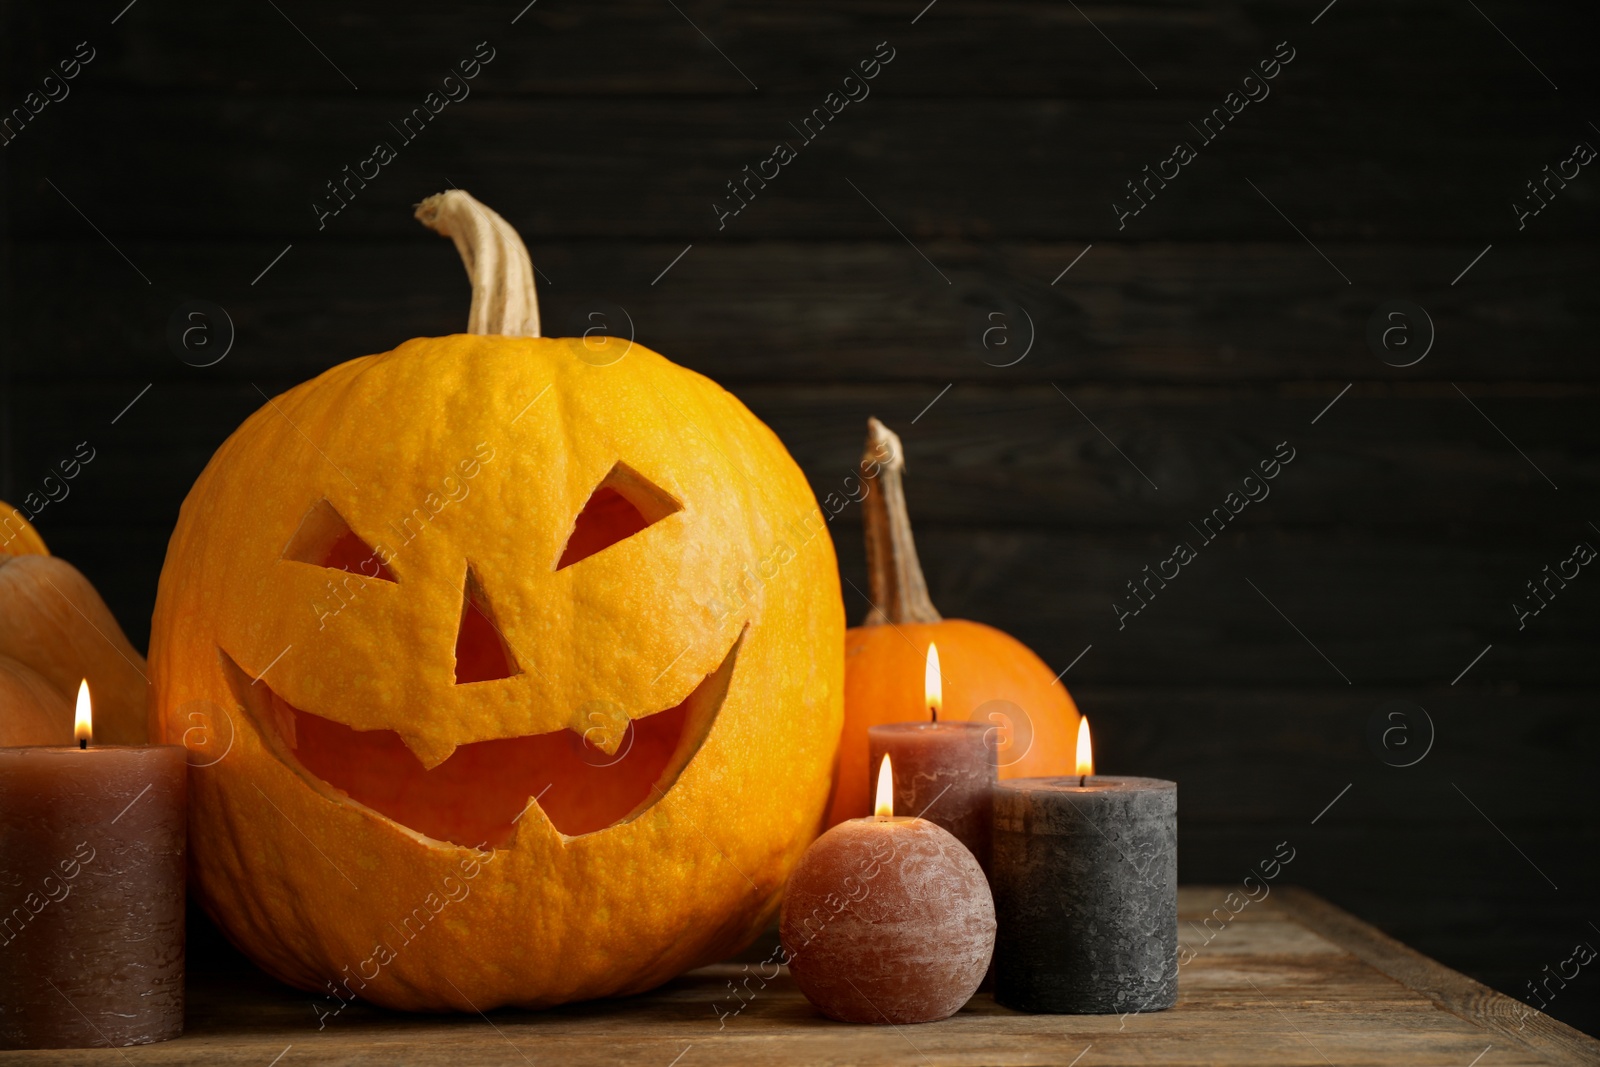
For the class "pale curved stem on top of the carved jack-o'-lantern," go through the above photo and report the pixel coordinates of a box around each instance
[416,189,539,338]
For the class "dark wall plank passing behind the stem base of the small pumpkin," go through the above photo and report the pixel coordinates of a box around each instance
[21,489,1600,689]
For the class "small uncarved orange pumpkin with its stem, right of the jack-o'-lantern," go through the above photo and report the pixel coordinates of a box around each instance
[827,419,1078,825]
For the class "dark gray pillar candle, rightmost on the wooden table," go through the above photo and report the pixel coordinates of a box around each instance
[989,774,1178,1014]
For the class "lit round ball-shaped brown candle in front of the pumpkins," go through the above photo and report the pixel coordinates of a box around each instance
[779,755,995,1025]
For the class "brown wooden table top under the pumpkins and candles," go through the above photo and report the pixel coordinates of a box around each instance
[6,886,1600,1067]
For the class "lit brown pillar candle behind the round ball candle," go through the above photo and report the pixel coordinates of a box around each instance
[867,643,998,873]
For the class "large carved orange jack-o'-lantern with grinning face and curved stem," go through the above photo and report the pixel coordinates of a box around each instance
[150,192,843,1014]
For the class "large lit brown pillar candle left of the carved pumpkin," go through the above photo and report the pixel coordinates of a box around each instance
[0,685,187,1049]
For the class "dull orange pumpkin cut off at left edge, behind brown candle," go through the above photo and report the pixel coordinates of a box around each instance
[0,502,149,745]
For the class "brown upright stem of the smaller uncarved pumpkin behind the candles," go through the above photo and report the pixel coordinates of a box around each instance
[861,419,942,625]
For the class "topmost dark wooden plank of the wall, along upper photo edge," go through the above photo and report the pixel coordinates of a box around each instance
[10,0,1582,99]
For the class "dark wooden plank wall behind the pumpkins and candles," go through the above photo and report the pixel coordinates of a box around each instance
[0,0,1600,1030]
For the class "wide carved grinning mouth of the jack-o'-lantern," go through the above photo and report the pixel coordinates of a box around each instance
[219,633,744,846]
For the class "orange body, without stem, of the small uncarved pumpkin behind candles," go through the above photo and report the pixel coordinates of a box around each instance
[827,619,1078,825]
